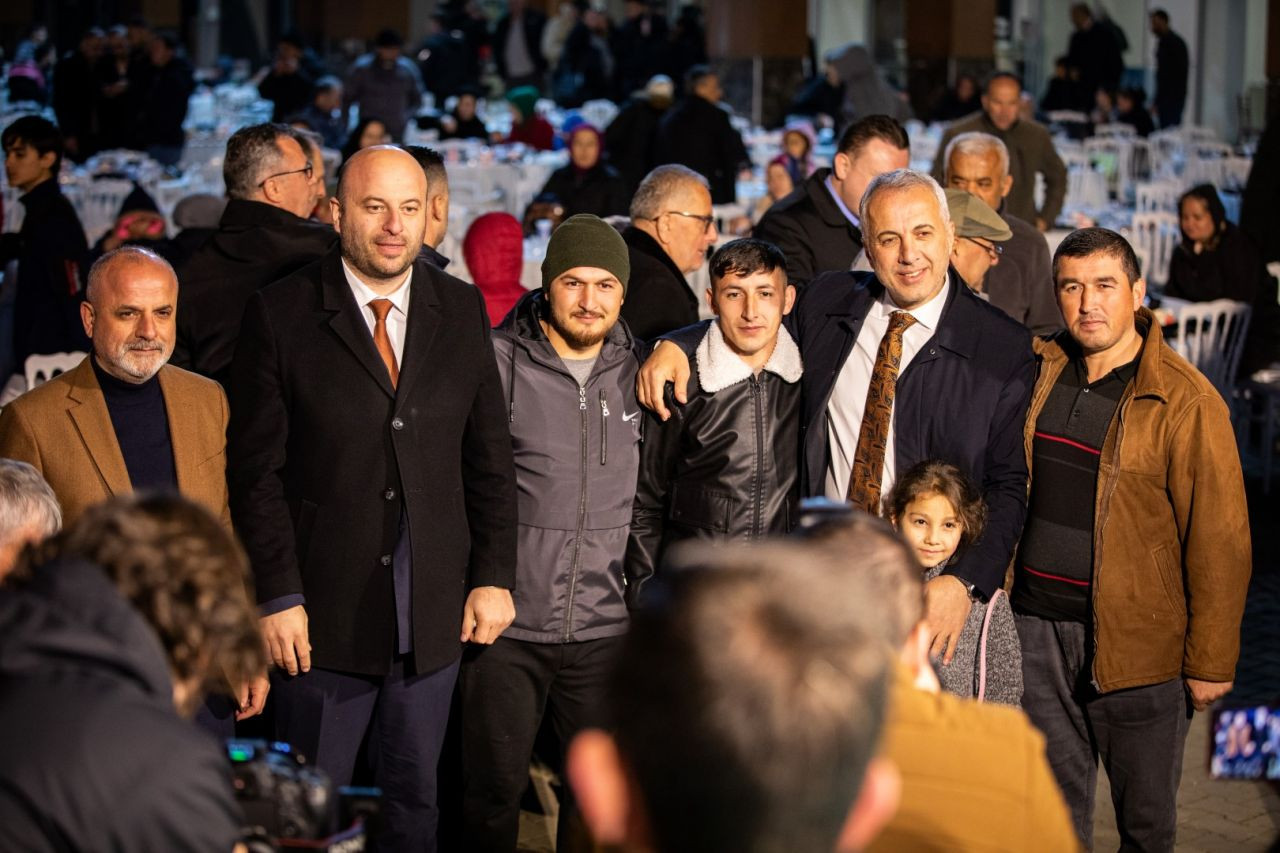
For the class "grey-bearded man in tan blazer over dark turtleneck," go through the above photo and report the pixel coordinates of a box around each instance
[0,246,268,736]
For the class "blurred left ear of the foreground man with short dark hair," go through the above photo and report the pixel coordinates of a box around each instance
[564,729,631,845]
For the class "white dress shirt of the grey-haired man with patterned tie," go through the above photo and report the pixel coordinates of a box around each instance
[823,282,951,501]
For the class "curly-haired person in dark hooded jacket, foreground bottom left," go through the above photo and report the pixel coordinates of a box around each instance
[0,494,266,850]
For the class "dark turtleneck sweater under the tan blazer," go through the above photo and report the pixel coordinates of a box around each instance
[90,356,178,492]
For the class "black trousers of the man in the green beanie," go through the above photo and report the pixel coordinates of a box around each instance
[460,637,622,853]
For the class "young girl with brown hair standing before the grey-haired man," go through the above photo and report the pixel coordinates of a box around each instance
[886,461,1023,707]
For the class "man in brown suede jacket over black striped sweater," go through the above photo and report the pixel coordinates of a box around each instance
[1011,228,1251,850]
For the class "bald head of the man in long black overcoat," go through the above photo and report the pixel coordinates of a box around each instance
[330,145,426,293]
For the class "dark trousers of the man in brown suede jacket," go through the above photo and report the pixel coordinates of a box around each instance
[1015,613,1192,852]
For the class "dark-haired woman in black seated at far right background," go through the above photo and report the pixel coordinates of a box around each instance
[1165,183,1280,375]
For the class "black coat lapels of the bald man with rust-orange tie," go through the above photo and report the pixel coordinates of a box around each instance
[320,246,443,397]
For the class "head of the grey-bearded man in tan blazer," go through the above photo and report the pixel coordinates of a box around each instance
[81,246,178,384]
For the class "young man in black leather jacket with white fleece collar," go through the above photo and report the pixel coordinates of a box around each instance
[627,240,803,581]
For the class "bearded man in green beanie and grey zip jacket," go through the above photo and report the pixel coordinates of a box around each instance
[461,214,641,850]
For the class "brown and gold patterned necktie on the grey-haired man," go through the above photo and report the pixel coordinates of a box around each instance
[849,311,915,515]
